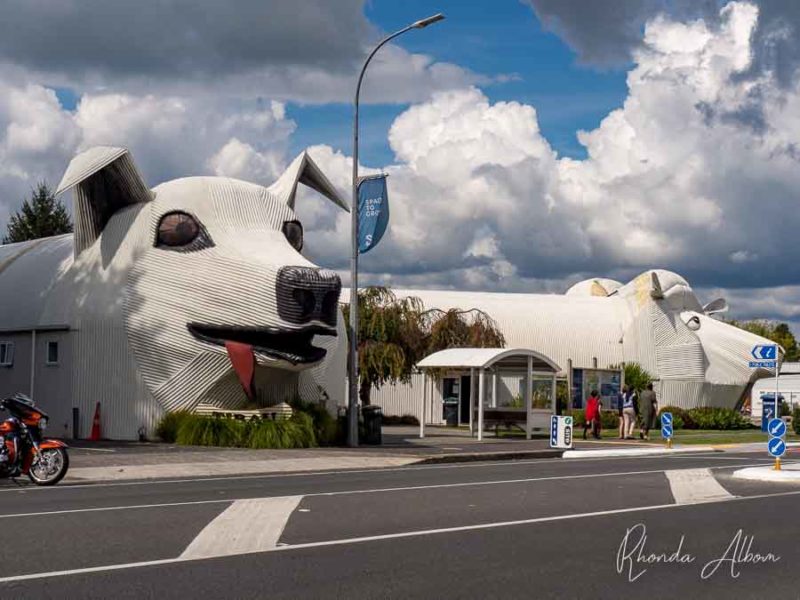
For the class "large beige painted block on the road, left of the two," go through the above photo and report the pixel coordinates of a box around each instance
[178,496,303,560]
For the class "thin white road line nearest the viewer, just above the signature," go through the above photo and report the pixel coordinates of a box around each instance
[0,491,800,583]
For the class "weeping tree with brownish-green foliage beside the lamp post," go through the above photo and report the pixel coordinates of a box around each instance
[344,287,505,405]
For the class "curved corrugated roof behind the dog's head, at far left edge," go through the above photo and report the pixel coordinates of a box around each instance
[0,233,73,331]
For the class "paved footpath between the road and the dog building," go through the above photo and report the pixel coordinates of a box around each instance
[54,427,732,483]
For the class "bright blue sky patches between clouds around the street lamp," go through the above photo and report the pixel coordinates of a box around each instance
[287,0,626,166]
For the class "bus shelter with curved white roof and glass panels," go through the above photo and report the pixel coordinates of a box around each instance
[417,348,561,440]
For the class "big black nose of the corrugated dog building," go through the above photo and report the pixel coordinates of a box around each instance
[276,267,342,327]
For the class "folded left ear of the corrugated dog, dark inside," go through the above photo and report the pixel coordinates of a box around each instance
[56,146,153,257]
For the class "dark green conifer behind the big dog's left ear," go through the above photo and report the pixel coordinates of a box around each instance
[3,181,72,244]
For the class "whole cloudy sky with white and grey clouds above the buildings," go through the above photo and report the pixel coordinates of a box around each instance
[0,0,800,332]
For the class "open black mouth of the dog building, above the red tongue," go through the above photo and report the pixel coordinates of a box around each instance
[187,323,336,365]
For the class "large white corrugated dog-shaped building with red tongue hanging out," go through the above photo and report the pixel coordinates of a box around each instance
[0,147,349,439]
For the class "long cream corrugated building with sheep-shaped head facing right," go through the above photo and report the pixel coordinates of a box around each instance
[366,270,783,424]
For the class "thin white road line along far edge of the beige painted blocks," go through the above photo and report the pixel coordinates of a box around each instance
[0,462,776,519]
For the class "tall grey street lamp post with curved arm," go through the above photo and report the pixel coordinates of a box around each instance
[347,13,444,447]
